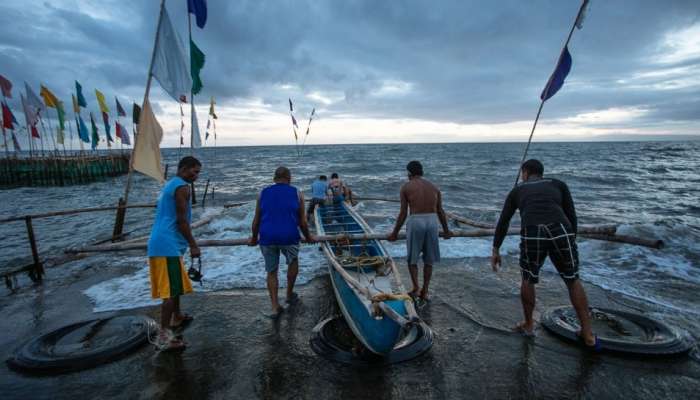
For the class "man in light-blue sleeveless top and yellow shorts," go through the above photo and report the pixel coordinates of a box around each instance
[148,156,202,350]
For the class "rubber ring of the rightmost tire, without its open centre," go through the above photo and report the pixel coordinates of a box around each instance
[541,306,693,356]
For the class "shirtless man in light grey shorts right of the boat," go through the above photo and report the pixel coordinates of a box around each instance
[388,161,452,301]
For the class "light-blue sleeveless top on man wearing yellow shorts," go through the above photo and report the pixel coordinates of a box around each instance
[148,176,192,257]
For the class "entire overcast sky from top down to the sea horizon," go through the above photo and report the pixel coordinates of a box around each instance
[0,0,700,146]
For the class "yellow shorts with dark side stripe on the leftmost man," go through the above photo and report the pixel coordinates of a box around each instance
[148,257,192,299]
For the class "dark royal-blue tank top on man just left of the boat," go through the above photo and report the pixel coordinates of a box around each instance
[259,183,299,246]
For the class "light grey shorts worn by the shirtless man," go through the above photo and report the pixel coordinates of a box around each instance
[406,214,440,265]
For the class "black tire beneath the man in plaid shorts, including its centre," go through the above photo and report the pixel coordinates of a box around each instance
[541,306,694,356]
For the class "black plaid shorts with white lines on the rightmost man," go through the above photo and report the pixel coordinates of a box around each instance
[520,224,578,283]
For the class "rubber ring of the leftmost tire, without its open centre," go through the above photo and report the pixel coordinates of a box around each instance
[6,316,155,374]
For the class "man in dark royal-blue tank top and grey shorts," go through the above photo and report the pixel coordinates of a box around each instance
[249,167,314,318]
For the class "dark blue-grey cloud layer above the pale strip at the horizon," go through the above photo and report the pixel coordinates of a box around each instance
[0,0,700,141]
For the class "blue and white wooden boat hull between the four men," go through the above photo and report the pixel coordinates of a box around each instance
[314,202,419,356]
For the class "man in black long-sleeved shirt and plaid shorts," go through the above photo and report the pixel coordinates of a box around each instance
[491,159,597,347]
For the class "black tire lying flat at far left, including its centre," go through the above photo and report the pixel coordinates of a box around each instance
[7,316,155,374]
